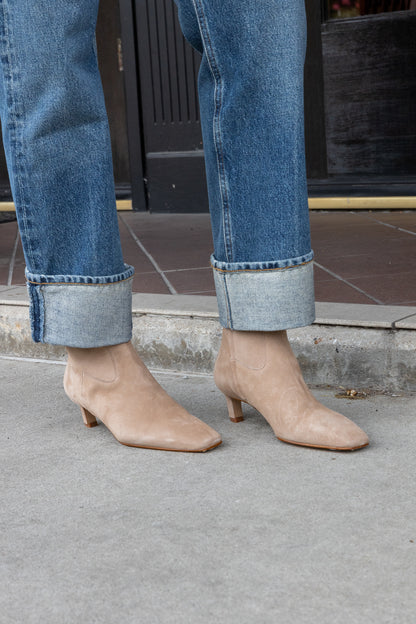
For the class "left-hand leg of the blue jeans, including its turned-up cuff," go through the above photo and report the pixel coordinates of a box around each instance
[0,0,134,347]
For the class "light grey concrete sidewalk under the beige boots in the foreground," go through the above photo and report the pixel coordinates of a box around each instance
[0,359,416,624]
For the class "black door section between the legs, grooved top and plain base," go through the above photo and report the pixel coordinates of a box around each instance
[135,0,209,212]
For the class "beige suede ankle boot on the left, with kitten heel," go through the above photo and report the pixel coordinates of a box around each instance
[64,342,221,452]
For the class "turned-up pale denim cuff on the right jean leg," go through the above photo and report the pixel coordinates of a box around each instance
[211,251,315,331]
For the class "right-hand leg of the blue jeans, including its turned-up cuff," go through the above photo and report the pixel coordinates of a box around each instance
[177,0,315,331]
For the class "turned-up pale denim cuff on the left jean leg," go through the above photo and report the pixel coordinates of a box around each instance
[26,264,134,348]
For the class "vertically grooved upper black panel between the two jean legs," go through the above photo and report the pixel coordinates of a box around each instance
[136,0,202,153]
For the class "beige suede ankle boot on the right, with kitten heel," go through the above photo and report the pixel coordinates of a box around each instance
[214,329,368,451]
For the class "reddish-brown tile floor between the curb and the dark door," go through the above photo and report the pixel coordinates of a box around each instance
[0,211,416,305]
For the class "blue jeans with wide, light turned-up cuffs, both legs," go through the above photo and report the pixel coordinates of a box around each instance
[0,0,315,347]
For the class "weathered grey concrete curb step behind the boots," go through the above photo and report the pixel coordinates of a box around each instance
[0,286,416,392]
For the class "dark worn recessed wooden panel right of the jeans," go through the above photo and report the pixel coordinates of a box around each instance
[322,11,416,182]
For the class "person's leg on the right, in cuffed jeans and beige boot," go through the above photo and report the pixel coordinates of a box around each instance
[177,0,368,449]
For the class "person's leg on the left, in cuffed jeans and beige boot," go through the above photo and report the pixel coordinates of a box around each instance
[0,0,221,451]
